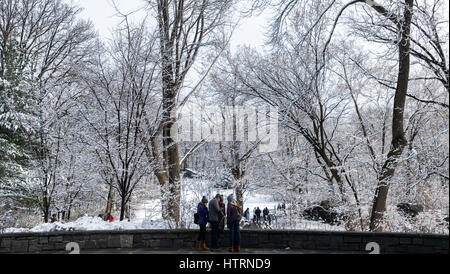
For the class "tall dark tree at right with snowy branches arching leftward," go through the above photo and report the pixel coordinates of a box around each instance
[248,0,414,231]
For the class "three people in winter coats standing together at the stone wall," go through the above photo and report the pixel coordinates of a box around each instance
[196,194,242,252]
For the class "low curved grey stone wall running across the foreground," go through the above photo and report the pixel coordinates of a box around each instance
[0,230,449,254]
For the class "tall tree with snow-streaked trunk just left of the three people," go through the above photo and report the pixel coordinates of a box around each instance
[147,0,234,226]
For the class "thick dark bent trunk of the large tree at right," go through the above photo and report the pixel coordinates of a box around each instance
[370,0,413,232]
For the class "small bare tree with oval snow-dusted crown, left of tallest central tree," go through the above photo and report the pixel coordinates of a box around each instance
[82,16,160,220]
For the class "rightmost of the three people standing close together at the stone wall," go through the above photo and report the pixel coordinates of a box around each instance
[227,194,242,252]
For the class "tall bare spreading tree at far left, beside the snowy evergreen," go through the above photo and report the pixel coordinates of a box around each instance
[0,0,94,222]
